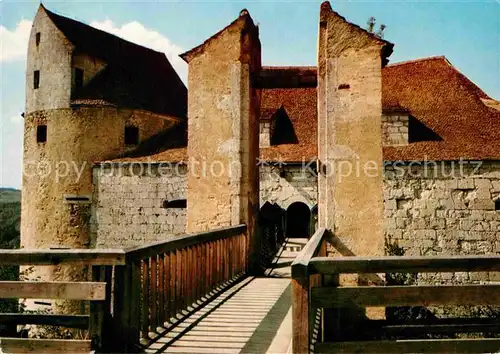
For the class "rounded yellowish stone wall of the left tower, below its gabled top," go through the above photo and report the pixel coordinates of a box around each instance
[21,107,174,312]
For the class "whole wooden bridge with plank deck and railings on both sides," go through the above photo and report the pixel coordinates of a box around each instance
[0,225,500,353]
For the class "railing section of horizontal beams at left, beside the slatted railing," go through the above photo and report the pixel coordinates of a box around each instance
[0,249,125,353]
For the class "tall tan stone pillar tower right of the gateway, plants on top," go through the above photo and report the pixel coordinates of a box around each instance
[318,2,393,256]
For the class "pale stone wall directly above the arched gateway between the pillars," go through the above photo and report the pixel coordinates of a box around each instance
[260,165,318,210]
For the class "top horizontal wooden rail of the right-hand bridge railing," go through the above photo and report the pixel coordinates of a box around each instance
[309,256,500,274]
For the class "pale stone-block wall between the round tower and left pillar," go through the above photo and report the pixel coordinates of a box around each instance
[91,163,187,248]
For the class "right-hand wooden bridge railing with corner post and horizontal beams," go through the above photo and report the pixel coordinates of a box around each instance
[292,233,500,353]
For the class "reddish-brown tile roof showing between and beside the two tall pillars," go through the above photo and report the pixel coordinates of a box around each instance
[107,57,500,162]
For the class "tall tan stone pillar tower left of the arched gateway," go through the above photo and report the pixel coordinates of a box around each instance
[182,10,261,272]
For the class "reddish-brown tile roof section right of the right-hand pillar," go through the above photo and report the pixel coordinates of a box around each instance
[382,57,500,160]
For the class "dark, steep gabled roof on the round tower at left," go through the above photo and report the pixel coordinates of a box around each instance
[40,5,187,117]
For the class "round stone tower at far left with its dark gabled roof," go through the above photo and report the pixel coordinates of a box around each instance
[21,5,187,302]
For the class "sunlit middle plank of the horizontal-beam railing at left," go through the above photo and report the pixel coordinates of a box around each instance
[0,281,106,300]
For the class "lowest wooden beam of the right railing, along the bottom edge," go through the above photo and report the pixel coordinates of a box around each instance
[314,338,500,354]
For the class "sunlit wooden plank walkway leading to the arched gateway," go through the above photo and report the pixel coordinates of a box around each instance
[145,238,300,354]
